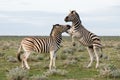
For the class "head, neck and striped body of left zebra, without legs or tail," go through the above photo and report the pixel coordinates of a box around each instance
[21,24,70,53]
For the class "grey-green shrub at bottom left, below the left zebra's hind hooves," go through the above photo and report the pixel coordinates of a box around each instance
[7,67,28,80]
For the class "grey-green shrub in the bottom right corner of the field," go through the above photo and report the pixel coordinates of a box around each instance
[100,64,120,78]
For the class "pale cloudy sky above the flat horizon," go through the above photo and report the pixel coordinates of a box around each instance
[0,0,120,36]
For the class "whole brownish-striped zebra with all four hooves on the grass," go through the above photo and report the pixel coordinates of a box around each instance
[17,24,70,70]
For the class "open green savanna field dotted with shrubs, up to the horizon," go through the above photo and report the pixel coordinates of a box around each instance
[0,36,120,80]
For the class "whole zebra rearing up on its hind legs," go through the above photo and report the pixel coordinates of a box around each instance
[64,10,102,68]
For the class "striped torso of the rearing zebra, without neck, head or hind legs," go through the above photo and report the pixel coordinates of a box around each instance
[67,24,102,47]
